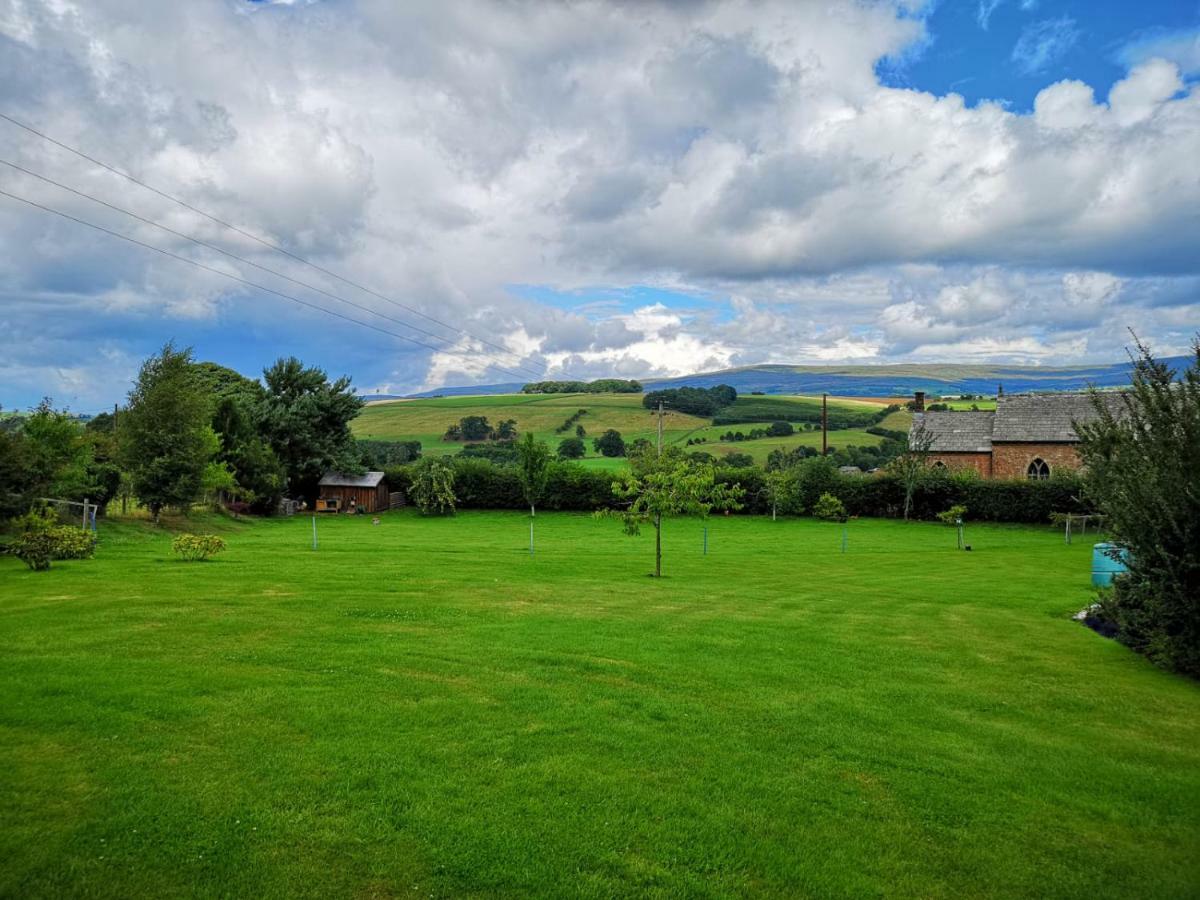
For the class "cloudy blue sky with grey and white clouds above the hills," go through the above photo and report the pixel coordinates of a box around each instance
[0,0,1200,412]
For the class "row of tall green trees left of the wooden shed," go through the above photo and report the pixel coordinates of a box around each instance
[0,344,362,528]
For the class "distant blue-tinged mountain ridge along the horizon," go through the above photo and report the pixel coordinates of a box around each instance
[381,356,1189,400]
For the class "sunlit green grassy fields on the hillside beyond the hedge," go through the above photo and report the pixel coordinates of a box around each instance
[353,394,907,467]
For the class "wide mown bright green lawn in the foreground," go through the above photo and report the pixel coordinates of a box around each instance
[0,512,1200,900]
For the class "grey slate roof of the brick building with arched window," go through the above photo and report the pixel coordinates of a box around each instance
[910,392,1124,454]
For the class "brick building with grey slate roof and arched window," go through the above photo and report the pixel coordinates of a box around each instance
[910,394,1123,479]
